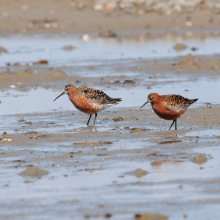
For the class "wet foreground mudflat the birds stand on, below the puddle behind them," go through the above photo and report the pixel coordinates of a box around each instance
[0,105,220,219]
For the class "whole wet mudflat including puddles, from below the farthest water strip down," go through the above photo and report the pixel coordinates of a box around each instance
[0,39,220,219]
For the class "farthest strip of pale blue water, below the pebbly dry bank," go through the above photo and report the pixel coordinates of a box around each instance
[0,35,220,67]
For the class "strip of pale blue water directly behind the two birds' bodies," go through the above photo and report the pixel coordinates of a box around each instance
[0,80,217,115]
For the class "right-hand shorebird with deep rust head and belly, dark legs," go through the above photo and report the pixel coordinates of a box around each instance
[141,93,198,130]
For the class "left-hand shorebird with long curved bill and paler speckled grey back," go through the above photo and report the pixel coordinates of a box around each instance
[54,84,121,125]
